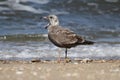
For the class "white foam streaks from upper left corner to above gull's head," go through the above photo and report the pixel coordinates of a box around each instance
[0,0,69,15]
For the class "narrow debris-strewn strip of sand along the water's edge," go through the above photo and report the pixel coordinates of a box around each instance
[0,58,120,64]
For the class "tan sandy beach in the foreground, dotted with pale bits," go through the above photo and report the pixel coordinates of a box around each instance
[0,60,120,80]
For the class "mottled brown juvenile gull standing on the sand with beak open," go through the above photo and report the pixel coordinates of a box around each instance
[44,15,94,58]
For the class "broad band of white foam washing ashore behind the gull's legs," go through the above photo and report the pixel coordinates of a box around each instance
[0,42,120,59]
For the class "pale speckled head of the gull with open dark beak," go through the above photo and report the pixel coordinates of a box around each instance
[43,15,59,27]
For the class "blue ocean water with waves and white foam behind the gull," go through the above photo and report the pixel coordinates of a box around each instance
[0,0,120,60]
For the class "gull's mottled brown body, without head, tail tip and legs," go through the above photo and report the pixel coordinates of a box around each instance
[48,26,84,48]
